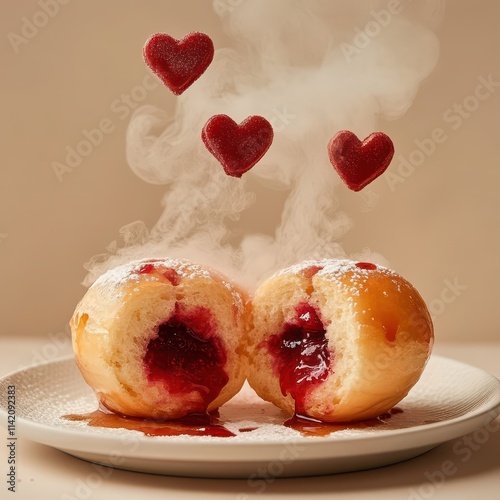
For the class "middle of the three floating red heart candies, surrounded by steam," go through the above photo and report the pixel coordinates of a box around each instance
[201,115,274,177]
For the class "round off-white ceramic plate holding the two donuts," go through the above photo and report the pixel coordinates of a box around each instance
[0,356,500,478]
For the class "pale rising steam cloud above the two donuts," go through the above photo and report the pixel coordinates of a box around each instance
[86,0,443,286]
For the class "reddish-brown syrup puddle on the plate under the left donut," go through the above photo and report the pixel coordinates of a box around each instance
[63,410,235,437]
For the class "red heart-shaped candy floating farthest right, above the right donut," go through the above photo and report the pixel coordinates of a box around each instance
[328,130,394,191]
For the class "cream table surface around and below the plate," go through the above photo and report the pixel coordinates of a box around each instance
[0,336,500,500]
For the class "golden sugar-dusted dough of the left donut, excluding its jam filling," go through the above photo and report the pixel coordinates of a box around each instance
[70,259,250,419]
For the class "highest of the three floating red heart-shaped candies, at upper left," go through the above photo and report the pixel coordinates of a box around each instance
[142,32,214,95]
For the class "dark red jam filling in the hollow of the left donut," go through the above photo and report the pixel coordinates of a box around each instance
[144,304,229,413]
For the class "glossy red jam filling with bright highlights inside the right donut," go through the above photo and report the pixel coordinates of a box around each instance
[267,302,330,415]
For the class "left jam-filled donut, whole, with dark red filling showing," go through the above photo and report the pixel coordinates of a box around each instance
[71,259,249,419]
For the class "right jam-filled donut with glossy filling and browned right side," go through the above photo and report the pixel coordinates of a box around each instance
[248,259,434,422]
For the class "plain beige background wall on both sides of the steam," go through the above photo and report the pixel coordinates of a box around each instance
[0,0,500,340]
